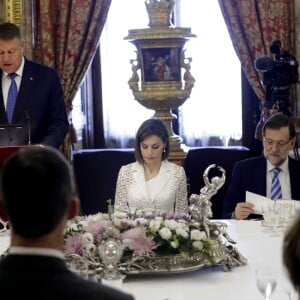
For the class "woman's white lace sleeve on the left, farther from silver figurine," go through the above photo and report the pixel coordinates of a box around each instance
[115,166,128,211]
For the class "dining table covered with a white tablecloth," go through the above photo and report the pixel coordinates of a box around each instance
[0,220,296,300]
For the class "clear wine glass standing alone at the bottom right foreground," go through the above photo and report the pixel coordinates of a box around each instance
[255,267,277,300]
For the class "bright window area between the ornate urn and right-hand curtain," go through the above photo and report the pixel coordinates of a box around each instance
[176,0,242,146]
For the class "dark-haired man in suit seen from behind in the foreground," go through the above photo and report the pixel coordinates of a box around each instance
[0,146,133,300]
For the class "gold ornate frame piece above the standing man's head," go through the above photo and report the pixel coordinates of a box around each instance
[0,0,23,26]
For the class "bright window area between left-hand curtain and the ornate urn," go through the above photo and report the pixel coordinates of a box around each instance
[100,0,153,147]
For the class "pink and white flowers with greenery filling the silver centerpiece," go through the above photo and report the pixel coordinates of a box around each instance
[64,211,216,273]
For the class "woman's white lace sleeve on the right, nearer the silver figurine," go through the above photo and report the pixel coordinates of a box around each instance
[175,167,188,213]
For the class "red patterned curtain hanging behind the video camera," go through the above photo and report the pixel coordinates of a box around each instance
[219,0,295,101]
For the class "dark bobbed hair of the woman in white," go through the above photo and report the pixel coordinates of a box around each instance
[134,118,170,163]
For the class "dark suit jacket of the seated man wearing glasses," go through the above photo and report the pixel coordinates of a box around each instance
[223,156,300,219]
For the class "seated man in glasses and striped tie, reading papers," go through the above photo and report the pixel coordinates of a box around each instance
[223,114,300,220]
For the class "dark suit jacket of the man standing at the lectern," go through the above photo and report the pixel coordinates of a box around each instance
[0,59,69,148]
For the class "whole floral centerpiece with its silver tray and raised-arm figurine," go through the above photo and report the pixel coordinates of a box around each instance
[64,164,247,279]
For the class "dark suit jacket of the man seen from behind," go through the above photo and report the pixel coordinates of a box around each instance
[0,254,134,300]
